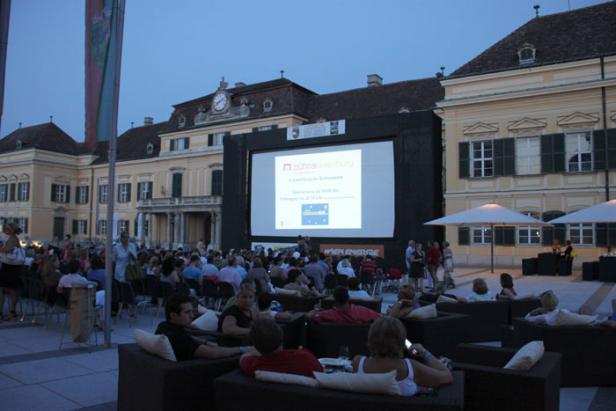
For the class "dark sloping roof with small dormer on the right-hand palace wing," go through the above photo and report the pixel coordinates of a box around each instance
[448,1,616,78]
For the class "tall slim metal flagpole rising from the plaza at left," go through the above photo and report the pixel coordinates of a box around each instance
[104,0,124,348]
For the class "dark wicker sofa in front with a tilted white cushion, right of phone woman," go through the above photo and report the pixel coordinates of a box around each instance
[454,344,562,411]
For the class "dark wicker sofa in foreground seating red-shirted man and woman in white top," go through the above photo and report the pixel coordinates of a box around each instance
[214,371,464,411]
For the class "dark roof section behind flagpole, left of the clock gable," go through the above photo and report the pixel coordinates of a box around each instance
[92,121,167,164]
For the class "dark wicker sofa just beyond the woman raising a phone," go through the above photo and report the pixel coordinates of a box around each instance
[402,311,468,358]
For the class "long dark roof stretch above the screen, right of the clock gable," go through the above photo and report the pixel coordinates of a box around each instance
[308,77,444,121]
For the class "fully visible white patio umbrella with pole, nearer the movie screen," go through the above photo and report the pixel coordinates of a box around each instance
[424,203,552,272]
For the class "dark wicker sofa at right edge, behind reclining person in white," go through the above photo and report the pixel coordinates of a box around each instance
[512,318,616,387]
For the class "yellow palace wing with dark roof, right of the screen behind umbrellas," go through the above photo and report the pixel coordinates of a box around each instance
[435,1,616,265]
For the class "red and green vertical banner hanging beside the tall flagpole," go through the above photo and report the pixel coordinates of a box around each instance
[85,0,124,147]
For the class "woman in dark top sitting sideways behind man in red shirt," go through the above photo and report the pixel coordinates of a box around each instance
[218,287,259,347]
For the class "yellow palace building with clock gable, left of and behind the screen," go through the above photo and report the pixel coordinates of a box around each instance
[0,74,443,248]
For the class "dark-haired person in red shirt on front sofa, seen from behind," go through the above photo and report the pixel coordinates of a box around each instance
[240,318,323,378]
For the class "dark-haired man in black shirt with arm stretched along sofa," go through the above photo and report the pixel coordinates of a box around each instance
[156,293,246,361]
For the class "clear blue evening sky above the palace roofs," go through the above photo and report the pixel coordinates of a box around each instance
[0,0,604,141]
